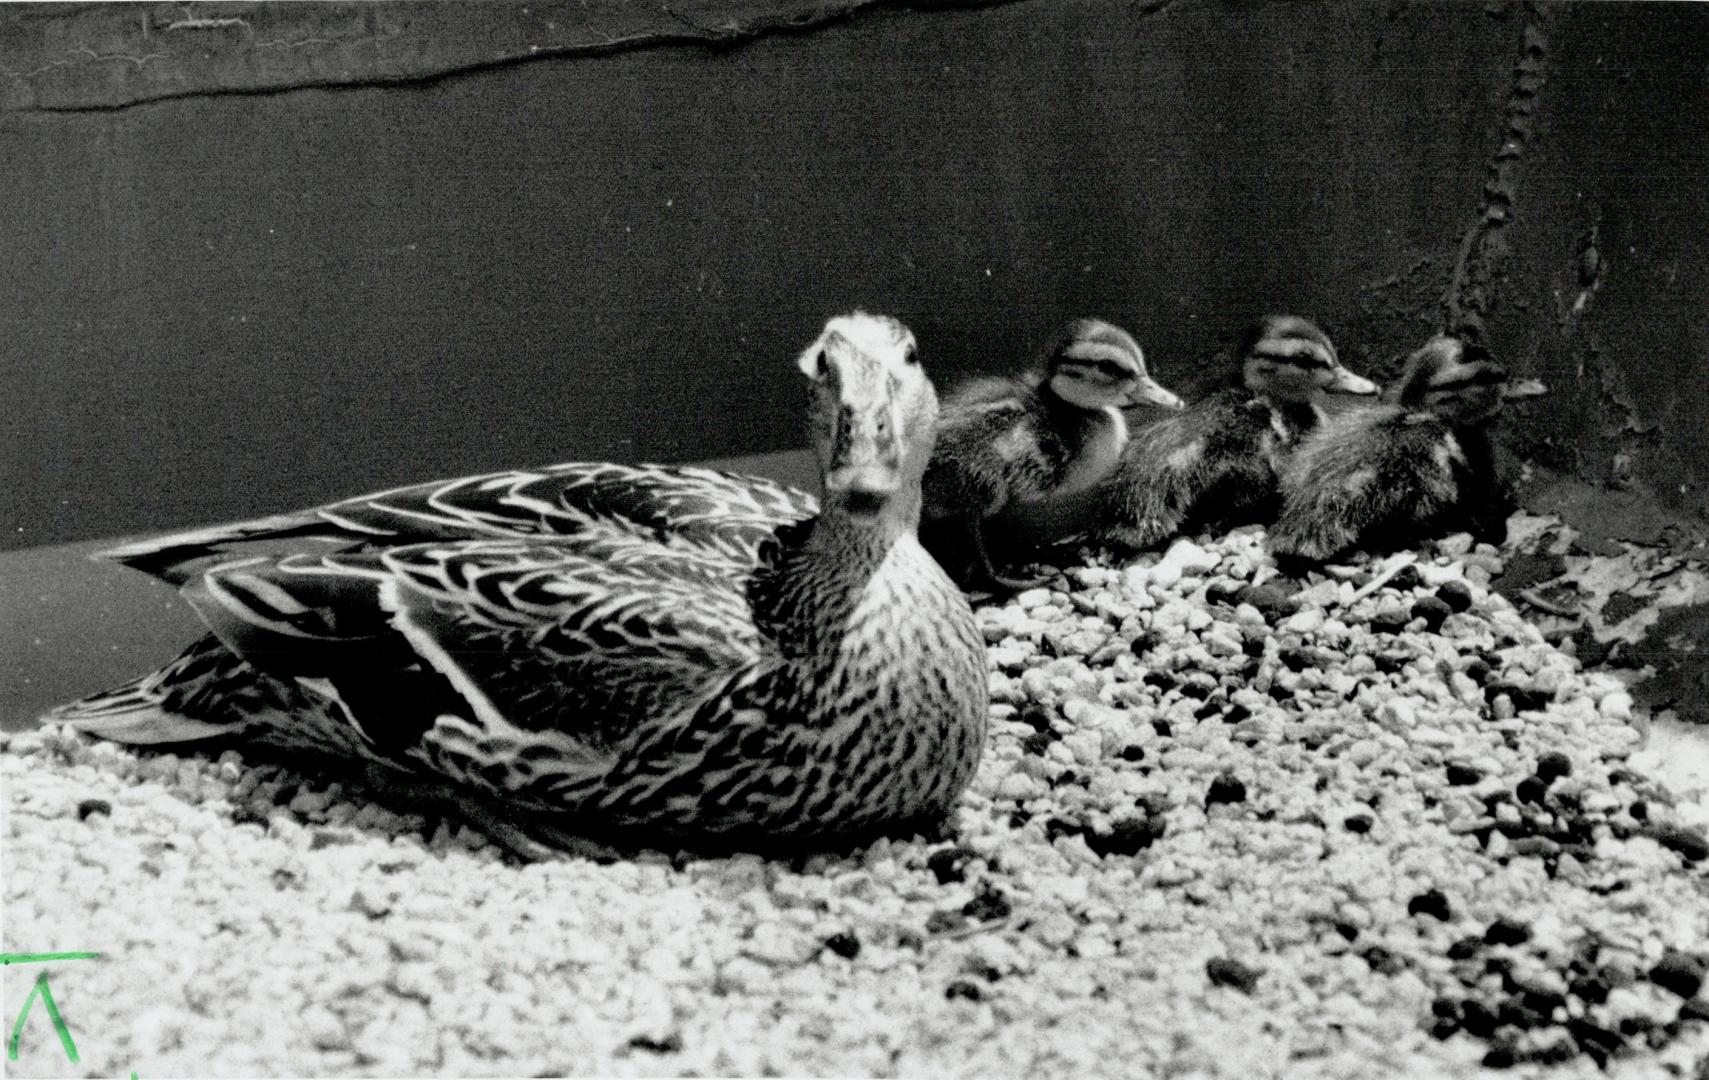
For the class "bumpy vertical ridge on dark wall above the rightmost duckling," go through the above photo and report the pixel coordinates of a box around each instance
[1442,3,1548,340]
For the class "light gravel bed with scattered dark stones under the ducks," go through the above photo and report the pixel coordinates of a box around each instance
[0,519,1709,1078]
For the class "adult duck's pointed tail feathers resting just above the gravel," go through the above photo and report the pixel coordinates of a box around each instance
[43,634,258,745]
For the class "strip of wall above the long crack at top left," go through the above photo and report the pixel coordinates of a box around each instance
[0,0,1039,114]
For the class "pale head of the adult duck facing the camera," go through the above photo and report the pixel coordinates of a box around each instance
[796,311,938,518]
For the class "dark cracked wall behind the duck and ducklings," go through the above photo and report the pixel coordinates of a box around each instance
[0,0,1709,547]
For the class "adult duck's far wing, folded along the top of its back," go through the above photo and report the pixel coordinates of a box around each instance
[101,461,819,584]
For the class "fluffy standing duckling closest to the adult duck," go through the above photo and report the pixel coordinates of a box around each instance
[923,318,1181,590]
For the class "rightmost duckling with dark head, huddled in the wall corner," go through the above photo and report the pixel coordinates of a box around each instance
[1270,337,1545,561]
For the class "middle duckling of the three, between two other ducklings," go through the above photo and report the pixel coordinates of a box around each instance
[1092,314,1377,550]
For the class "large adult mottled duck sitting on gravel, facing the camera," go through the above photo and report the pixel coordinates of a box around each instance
[50,313,988,849]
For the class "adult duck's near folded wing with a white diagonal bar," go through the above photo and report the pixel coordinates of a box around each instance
[58,538,771,805]
